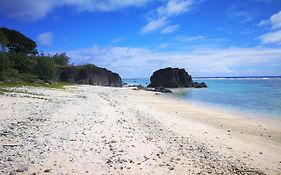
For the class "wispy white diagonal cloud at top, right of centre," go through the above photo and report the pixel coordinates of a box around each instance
[140,0,194,34]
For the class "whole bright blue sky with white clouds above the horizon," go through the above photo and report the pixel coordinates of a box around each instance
[0,0,281,78]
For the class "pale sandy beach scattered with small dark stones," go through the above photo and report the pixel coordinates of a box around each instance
[0,86,281,175]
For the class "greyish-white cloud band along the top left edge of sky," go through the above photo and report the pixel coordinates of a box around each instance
[0,0,153,21]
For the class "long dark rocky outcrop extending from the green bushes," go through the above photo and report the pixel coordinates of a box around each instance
[59,64,122,87]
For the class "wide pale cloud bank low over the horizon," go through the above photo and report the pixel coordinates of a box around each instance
[61,46,281,77]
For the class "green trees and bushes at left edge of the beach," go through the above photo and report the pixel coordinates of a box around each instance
[0,27,83,86]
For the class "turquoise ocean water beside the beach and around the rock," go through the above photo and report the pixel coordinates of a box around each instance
[123,77,281,119]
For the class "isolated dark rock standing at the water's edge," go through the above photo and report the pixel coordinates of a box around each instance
[148,67,207,88]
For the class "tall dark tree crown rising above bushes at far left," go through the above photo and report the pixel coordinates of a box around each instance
[0,27,37,55]
